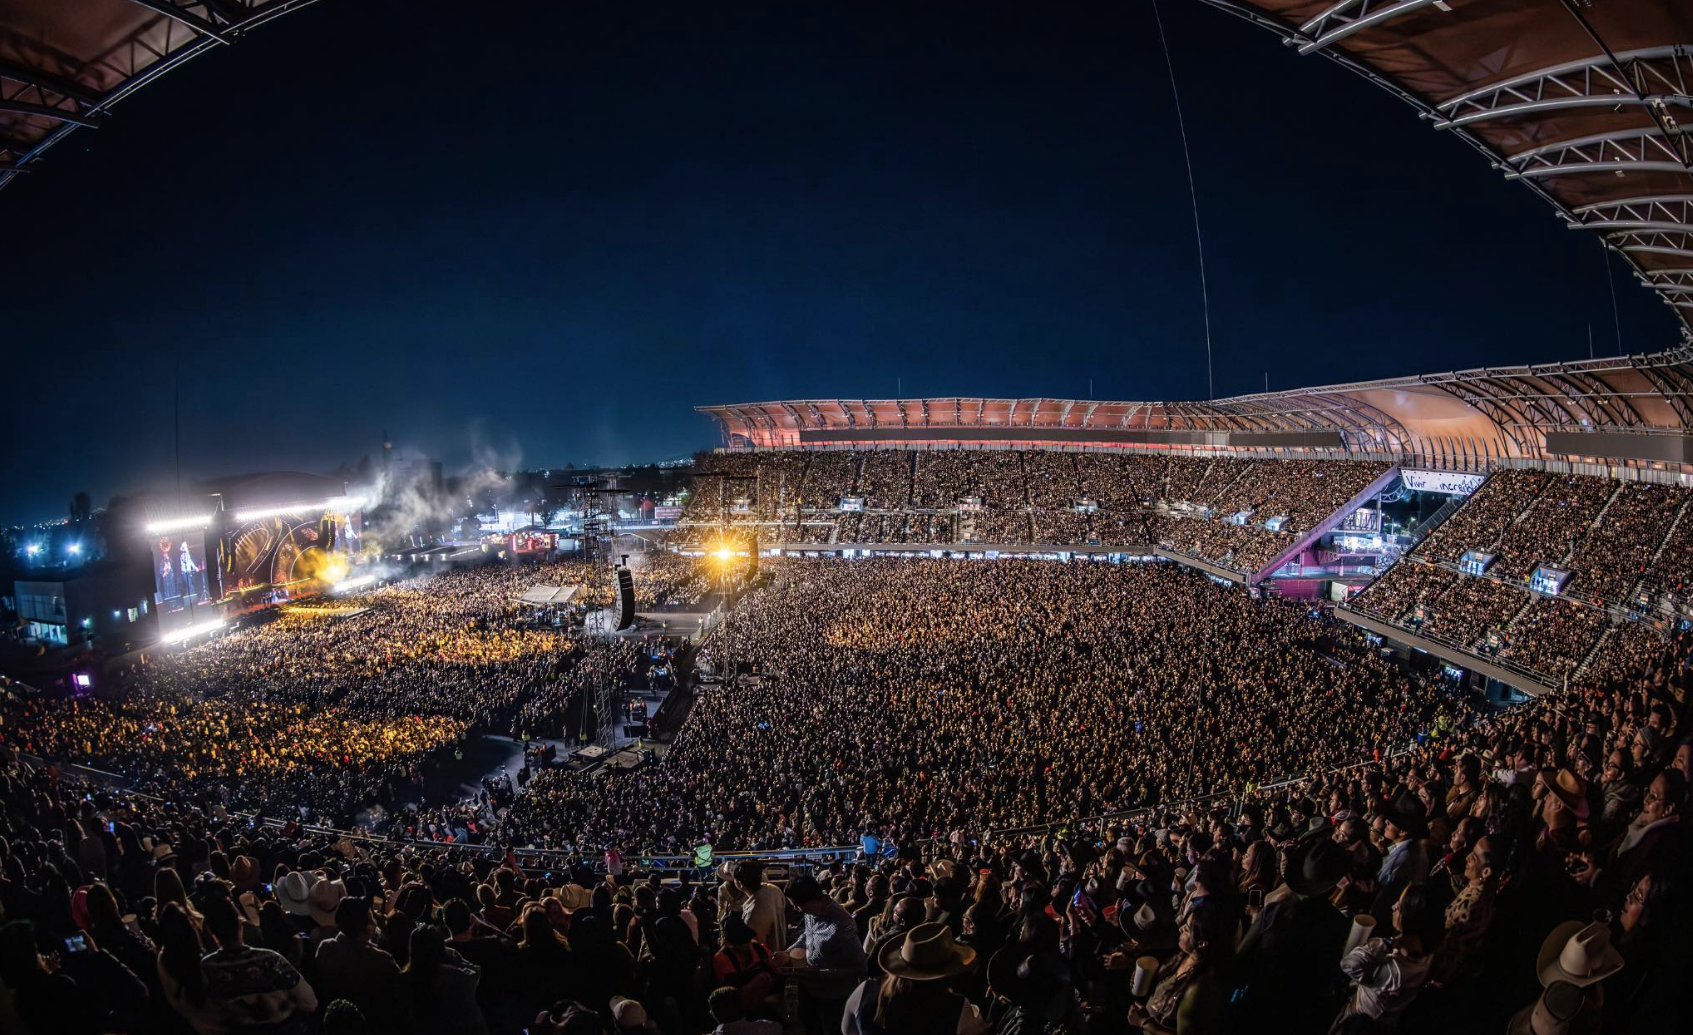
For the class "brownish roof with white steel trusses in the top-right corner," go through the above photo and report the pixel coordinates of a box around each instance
[1205,0,1693,339]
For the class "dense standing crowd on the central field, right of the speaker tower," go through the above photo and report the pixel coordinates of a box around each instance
[487,559,1444,849]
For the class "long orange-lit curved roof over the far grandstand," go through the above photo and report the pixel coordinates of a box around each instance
[699,346,1693,471]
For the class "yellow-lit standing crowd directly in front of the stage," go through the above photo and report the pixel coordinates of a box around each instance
[7,554,677,825]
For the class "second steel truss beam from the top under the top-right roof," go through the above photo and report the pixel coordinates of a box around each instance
[1434,44,1693,129]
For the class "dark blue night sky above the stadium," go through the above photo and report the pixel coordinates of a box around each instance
[0,0,1678,522]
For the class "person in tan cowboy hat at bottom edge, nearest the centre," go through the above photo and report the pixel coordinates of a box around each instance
[858,923,989,1035]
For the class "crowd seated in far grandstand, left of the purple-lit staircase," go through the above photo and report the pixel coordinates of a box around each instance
[679,449,1387,571]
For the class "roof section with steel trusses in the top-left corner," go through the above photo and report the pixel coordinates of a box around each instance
[0,0,313,188]
